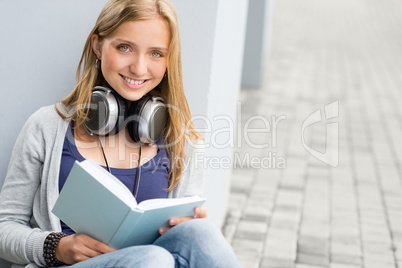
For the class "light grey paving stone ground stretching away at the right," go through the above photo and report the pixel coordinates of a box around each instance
[223,0,402,268]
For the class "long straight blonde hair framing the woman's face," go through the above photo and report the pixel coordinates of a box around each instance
[56,0,201,190]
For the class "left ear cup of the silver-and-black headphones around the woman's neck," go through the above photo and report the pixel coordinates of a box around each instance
[84,86,128,136]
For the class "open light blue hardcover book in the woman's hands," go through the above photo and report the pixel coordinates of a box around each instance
[52,159,205,249]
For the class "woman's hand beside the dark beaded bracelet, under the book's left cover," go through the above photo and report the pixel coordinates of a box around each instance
[56,234,115,265]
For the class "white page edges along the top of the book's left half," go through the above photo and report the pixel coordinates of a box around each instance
[78,159,137,208]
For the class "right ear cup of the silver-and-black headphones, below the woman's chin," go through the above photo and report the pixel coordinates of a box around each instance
[127,95,167,144]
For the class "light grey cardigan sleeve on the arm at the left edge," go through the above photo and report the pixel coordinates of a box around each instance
[0,110,53,266]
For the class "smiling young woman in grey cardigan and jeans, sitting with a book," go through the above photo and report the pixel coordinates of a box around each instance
[0,0,240,268]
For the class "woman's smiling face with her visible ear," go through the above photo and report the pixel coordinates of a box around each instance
[92,18,170,101]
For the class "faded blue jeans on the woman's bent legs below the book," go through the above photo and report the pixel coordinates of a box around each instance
[59,219,241,268]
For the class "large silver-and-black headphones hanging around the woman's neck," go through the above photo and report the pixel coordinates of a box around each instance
[84,86,167,145]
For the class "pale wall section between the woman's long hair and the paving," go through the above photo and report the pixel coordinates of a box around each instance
[173,0,248,226]
